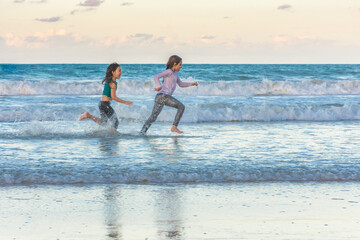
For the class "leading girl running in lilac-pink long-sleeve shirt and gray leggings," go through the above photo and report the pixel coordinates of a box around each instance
[140,55,198,135]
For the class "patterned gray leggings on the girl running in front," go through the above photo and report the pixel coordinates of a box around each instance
[140,93,185,134]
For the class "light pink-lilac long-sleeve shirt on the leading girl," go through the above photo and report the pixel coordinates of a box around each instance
[154,69,192,95]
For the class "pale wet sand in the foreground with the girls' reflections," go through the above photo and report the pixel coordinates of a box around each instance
[0,182,360,240]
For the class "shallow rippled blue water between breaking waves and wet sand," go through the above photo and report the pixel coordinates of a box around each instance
[0,122,360,185]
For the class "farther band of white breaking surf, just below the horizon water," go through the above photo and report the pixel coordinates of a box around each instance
[0,77,360,96]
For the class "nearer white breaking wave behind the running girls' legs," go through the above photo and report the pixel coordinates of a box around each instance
[0,101,360,123]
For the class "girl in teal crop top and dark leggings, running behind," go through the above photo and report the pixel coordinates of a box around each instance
[79,63,133,131]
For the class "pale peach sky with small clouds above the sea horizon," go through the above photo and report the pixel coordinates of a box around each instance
[0,0,360,64]
